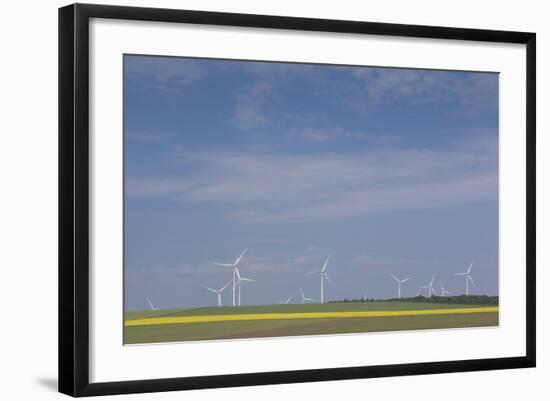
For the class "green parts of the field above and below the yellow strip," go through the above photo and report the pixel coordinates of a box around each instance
[124,301,498,344]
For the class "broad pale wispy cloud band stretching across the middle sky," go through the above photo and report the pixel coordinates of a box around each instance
[129,135,498,223]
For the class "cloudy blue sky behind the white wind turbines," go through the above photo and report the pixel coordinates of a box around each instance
[124,56,498,310]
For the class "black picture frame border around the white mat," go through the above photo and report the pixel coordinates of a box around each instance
[59,4,536,396]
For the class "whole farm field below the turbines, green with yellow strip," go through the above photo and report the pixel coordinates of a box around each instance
[124,301,498,344]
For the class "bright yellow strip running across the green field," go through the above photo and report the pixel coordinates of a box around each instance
[124,306,498,327]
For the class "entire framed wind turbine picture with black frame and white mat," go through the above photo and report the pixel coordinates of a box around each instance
[59,4,536,396]
